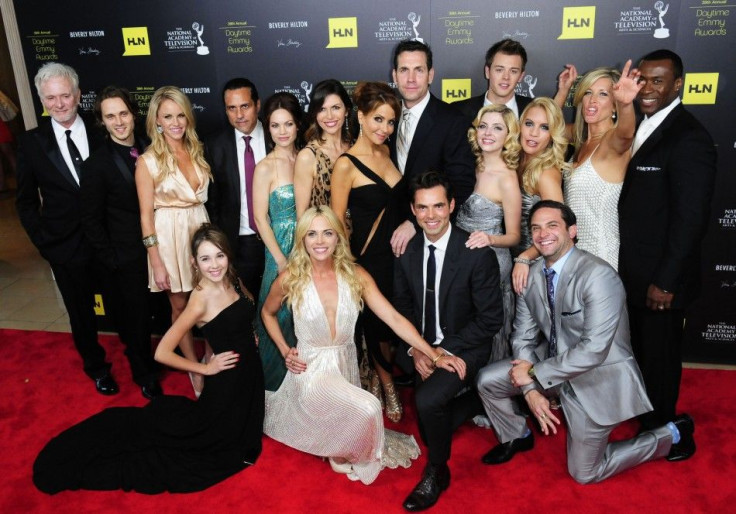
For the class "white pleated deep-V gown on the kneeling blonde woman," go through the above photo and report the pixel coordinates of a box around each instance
[263,277,420,484]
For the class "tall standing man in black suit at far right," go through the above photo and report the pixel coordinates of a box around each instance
[619,50,716,430]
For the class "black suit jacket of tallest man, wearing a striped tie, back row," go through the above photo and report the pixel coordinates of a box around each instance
[389,94,475,205]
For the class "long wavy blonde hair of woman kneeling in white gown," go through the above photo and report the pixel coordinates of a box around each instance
[282,205,363,310]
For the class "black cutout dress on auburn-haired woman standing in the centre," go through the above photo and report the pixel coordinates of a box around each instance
[343,154,409,370]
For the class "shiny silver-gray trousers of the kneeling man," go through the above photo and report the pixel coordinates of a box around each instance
[476,359,672,484]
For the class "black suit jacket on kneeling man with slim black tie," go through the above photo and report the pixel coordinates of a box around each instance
[394,226,503,372]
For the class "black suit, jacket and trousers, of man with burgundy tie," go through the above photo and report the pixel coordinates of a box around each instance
[205,127,265,298]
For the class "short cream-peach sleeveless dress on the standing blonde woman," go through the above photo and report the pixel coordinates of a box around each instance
[141,153,210,293]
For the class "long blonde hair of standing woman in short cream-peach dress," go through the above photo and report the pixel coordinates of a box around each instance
[146,86,212,183]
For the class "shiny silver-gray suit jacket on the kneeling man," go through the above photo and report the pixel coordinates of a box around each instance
[511,248,652,425]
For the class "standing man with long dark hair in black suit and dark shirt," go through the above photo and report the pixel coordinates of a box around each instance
[79,86,162,400]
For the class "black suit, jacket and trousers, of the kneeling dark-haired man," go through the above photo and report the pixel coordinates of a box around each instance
[394,227,503,465]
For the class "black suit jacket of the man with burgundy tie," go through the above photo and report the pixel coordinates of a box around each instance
[205,126,267,248]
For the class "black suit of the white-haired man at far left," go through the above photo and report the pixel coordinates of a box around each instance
[17,120,109,378]
